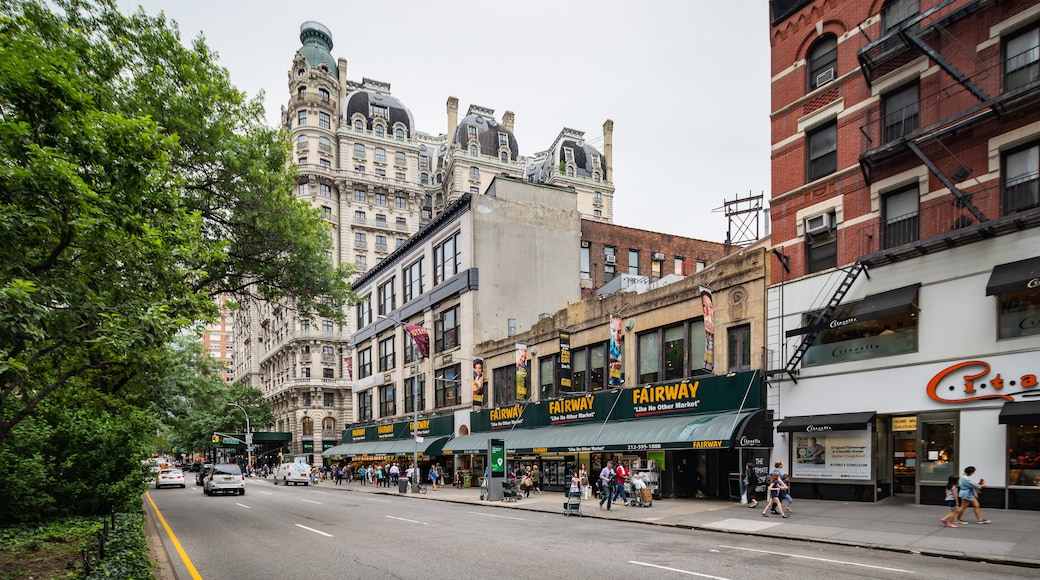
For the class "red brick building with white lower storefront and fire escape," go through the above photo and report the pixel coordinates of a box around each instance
[768,0,1040,509]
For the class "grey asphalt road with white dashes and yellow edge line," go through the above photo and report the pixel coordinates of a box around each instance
[149,479,1036,580]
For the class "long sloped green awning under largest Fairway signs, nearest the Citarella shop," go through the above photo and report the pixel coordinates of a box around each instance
[444,410,758,455]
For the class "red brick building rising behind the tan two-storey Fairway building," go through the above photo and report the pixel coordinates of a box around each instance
[581,219,728,298]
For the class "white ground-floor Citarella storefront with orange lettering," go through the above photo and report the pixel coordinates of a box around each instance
[774,351,1040,509]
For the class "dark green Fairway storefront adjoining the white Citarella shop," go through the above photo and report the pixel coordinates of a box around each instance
[443,371,772,499]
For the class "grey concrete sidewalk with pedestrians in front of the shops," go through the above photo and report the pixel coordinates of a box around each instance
[318,479,1040,568]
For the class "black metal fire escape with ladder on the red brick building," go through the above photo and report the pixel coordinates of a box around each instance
[781,0,1040,379]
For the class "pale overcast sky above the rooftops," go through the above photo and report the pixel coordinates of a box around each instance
[118,0,770,242]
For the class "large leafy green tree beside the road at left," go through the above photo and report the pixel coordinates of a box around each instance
[0,0,355,447]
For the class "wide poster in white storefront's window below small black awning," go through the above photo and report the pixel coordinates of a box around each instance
[790,430,870,479]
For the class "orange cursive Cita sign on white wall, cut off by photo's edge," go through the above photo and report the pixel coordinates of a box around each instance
[928,361,1040,403]
